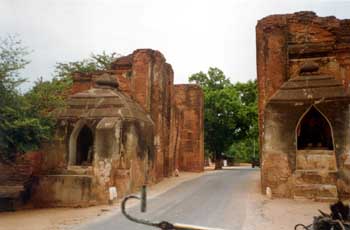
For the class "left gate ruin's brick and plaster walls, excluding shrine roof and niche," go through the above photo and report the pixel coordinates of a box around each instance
[23,49,204,207]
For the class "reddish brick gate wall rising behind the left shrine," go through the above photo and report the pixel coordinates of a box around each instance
[68,49,204,181]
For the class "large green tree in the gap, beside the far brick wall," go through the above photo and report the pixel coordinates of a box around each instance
[189,68,250,169]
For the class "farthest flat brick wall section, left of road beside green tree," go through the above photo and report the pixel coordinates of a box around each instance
[171,84,204,172]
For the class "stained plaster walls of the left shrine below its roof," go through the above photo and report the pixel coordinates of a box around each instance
[32,117,154,207]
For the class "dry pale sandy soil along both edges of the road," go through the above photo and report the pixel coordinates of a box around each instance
[0,167,336,230]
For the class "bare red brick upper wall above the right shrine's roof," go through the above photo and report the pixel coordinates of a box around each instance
[256,12,350,120]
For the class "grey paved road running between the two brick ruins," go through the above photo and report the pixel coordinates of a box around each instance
[78,168,258,230]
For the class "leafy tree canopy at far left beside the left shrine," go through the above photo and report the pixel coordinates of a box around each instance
[0,36,117,159]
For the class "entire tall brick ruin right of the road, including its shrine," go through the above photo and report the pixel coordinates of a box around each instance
[256,12,350,200]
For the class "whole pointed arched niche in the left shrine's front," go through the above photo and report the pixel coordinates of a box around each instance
[68,120,94,165]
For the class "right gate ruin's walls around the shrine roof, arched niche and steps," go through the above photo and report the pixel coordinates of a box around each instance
[256,12,350,197]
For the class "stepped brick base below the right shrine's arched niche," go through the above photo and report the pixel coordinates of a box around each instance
[261,151,339,202]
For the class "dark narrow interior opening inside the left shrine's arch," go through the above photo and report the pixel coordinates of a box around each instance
[76,126,94,165]
